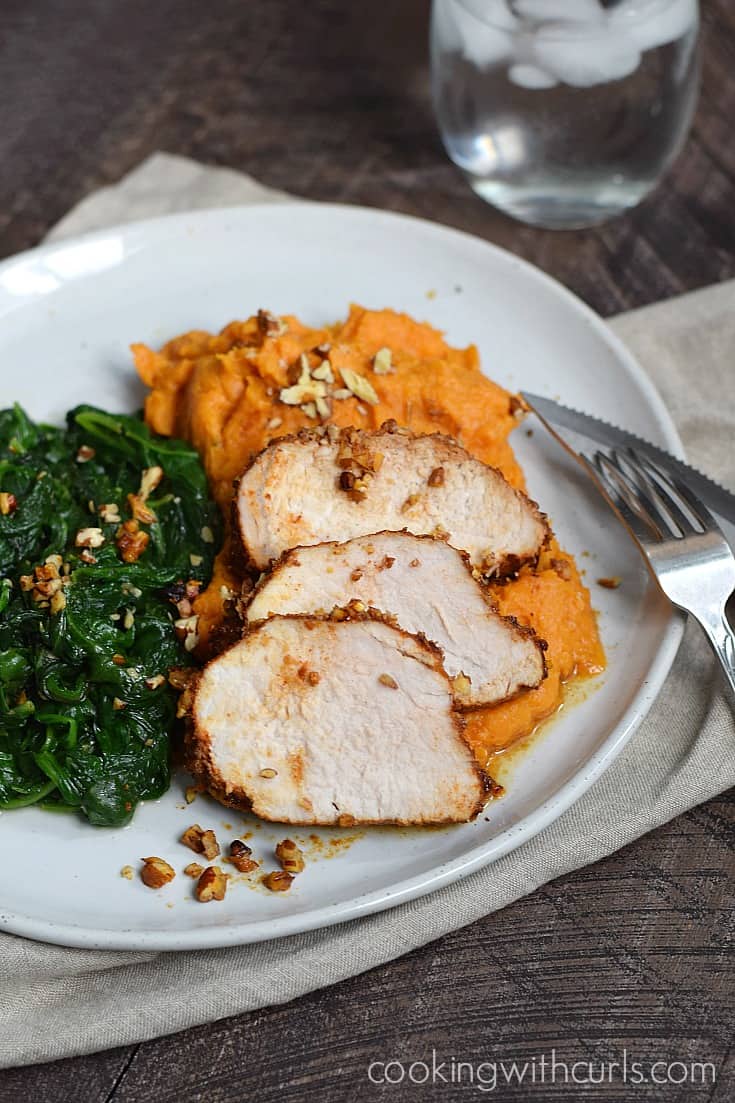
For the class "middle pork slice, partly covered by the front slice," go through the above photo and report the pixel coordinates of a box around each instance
[245,532,545,708]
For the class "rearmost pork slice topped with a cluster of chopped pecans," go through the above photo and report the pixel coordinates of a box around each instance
[235,424,548,576]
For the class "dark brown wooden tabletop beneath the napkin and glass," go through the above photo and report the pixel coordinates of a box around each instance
[0,0,735,1103]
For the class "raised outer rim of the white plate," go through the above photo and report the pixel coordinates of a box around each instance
[0,200,684,951]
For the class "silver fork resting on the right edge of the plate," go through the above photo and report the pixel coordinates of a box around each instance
[583,448,735,694]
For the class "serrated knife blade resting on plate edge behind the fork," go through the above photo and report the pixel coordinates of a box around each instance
[521,390,735,525]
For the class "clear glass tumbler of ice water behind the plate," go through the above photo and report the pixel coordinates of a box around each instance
[432,0,700,229]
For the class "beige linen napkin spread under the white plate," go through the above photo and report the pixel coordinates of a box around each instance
[0,154,735,1067]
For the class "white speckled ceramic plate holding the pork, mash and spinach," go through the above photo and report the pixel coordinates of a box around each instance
[0,204,681,950]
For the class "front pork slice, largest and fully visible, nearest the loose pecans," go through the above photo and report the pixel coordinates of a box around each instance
[187,617,487,825]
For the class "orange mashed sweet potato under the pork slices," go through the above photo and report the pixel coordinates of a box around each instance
[132,306,605,765]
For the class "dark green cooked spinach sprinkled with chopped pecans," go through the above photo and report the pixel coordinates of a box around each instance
[0,406,220,826]
